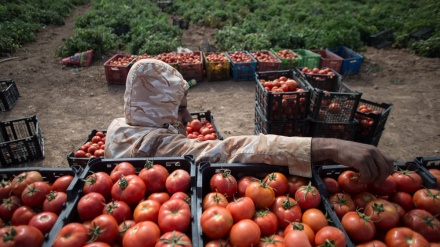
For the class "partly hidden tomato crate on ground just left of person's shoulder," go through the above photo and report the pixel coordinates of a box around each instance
[67,130,107,167]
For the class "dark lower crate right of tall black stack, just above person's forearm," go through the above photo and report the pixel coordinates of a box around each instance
[309,119,358,141]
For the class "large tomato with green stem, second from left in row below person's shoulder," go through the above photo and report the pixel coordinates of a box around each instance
[111,174,147,205]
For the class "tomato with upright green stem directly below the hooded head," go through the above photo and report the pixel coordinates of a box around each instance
[138,161,170,194]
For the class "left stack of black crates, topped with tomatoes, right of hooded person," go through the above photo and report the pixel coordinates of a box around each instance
[255,70,310,136]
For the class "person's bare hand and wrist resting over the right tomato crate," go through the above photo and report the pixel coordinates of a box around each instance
[311,138,394,183]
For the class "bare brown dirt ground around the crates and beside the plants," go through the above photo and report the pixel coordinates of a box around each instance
[0,6,440,167]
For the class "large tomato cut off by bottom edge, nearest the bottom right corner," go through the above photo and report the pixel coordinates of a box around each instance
[385,227,429,247]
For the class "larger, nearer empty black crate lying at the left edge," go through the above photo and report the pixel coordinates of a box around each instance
[0,116,44,168]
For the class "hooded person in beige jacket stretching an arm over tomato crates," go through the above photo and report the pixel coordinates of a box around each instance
[104,59,393,183]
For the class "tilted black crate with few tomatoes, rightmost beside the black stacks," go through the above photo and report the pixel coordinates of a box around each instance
[354,99,393,139]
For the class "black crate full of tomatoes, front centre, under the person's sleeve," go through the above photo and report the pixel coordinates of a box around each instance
[194,162,354,246]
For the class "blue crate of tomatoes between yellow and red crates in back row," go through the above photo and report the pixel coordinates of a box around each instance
[226,51,257,81]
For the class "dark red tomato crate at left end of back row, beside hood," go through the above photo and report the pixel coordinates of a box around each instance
[104,54,137,85]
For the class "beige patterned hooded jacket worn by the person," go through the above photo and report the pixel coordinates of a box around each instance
[105,59,312,177]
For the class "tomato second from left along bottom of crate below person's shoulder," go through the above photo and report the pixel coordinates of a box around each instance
[89,214,119,244]
